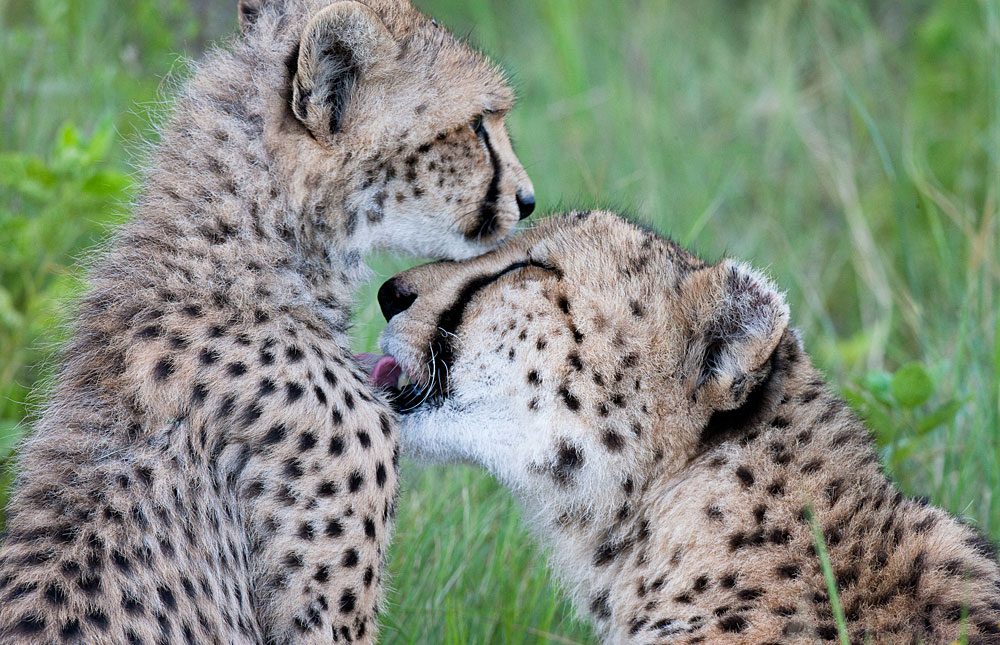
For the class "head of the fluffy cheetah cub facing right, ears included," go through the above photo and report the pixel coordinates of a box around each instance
[240,0,535,259]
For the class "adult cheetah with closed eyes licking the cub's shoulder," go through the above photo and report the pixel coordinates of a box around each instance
[382,213,1000,643]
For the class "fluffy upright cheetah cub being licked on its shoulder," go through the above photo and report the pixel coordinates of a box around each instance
[0,0,534,645]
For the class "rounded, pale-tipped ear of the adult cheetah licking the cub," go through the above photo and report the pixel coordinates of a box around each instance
[684,260,788,410]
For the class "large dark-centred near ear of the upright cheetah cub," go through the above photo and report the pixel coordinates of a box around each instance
[292,0,399,139]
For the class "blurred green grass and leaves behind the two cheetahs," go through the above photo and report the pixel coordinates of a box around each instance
[0,0,1000,643]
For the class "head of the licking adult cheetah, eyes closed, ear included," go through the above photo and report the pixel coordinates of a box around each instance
[380,212,788,514]
